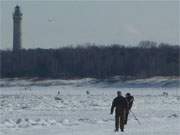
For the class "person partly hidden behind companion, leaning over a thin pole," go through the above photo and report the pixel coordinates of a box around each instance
[125,93,134,124]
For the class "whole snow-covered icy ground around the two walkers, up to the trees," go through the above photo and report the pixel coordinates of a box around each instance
[0,78,180,135]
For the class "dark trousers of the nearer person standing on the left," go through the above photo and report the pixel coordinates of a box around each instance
[115,111,125,131]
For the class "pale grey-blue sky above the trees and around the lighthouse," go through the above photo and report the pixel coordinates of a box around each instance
[0,0,180,49]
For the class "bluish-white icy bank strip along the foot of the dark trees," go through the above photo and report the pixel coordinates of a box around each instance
[0,76,180,87]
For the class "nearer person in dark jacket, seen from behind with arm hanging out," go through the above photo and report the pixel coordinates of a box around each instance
[111,91,128,132]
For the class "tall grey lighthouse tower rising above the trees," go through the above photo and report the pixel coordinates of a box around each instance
[13,5,22,51]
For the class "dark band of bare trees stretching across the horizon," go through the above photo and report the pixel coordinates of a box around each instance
[1,41,180,79]
